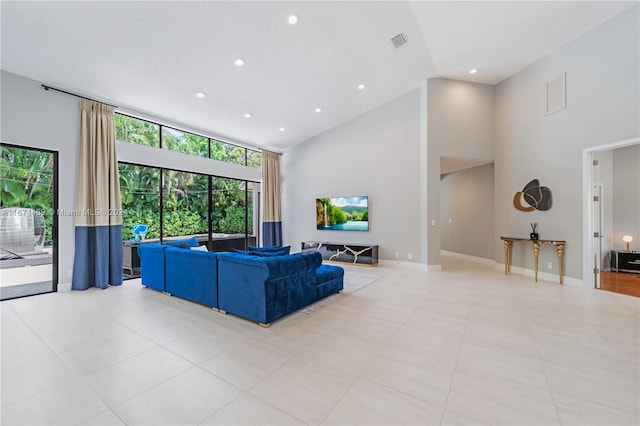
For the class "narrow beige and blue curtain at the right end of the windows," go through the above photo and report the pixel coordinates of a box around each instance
[262,150,282,246]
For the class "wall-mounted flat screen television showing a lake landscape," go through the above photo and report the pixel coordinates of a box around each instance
[316,195,369,231]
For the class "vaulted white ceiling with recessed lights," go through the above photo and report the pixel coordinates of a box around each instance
[0,1,638,152]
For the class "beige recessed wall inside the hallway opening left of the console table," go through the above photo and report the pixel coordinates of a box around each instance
[440,164,495,259]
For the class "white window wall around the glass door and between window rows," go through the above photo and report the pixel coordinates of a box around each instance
[0,71,261,287]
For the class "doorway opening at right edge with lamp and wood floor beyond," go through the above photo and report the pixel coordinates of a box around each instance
[583,138,640,297]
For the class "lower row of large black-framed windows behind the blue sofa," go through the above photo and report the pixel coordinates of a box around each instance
[119,163,259,278]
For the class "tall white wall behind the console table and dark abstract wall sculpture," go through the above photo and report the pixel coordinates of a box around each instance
[494,6,640,279]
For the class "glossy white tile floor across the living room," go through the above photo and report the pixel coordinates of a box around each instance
[0,258,640,425]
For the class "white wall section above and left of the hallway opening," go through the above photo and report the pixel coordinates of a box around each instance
[427,78,494,265]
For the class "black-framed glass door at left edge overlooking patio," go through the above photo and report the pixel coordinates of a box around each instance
[0,144,58,300]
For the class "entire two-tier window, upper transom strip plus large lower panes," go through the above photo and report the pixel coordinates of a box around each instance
[116,114,262,277]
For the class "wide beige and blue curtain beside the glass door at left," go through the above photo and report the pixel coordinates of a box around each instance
[71,99,122,290]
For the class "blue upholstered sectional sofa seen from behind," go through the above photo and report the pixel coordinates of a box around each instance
[138,240,344,326]
